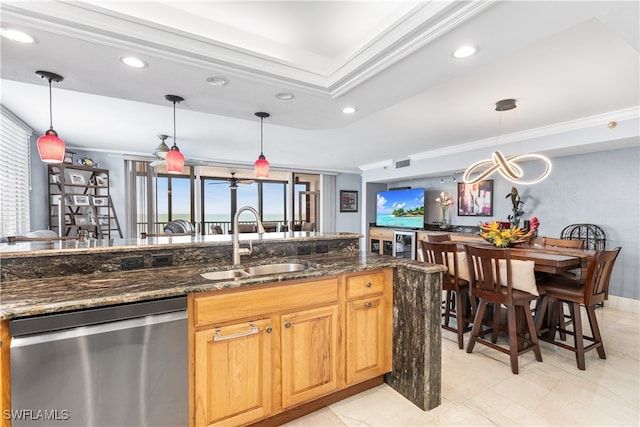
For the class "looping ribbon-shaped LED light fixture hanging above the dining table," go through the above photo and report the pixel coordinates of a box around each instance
[462,99,551,185]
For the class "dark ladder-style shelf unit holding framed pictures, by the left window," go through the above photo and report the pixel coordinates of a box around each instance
[47,163,122,238]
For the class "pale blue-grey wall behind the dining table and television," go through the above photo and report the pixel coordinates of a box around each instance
[366,146,640,299]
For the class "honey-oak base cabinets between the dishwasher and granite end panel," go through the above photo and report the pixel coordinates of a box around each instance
[189,269,392,426]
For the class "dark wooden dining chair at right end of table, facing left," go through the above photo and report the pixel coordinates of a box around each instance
[536,247,620,370]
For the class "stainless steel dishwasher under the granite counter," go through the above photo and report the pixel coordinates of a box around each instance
[9,297,188,427]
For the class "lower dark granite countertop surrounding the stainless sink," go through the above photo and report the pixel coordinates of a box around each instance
[0,251,445,319]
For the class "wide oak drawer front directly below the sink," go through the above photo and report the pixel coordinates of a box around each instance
[193,277,338,327]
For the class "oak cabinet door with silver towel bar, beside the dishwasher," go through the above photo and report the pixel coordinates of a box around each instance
[195,319,272,426]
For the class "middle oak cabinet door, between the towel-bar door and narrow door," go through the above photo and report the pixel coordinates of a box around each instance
[281,305,339,408]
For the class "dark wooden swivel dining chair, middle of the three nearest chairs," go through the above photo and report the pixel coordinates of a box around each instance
[465,245,542,374]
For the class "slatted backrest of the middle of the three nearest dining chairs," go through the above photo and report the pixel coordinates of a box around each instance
[464,245,513,304]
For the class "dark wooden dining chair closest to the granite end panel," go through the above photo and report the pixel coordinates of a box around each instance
[422,242,473,349]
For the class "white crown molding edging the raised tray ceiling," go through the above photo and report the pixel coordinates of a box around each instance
[2,0,495,98]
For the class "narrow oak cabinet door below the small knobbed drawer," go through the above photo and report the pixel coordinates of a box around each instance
[346,296,391,385]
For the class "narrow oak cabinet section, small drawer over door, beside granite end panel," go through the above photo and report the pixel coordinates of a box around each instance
[345,271,392,384]
